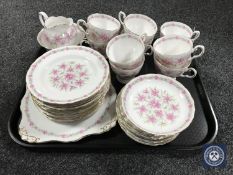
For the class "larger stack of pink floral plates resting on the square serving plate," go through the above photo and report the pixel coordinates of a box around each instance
[26,46,110,122]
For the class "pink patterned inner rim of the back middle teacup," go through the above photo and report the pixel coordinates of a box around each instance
[123,13,158,37]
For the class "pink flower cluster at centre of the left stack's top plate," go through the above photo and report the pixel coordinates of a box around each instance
[49,61,89,91]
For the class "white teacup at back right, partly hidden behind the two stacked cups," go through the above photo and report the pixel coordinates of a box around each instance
[160,21,200,42]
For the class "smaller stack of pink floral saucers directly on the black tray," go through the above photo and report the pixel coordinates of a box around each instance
[116,74,195,146]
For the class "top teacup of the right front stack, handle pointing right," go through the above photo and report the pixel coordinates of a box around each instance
[153,35,205,68]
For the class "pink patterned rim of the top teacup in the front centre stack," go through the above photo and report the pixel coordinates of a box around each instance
[106,33,145,67]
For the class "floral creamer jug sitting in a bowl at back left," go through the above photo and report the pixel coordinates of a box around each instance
[37,12,85,49]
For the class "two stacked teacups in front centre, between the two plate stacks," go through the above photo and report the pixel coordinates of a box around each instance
[106,33,151,84]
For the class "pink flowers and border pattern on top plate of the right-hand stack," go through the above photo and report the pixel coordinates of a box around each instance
[122,74,195,134]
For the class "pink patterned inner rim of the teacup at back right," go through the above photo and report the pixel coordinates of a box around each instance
[160,21,193,38]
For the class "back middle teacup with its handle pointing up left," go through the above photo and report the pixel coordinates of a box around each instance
[118,11,157,45]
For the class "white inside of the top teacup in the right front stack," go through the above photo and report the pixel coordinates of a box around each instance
[154,36,193,55]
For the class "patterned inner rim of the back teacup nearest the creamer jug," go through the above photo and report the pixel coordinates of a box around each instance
[87,13,121,32]
